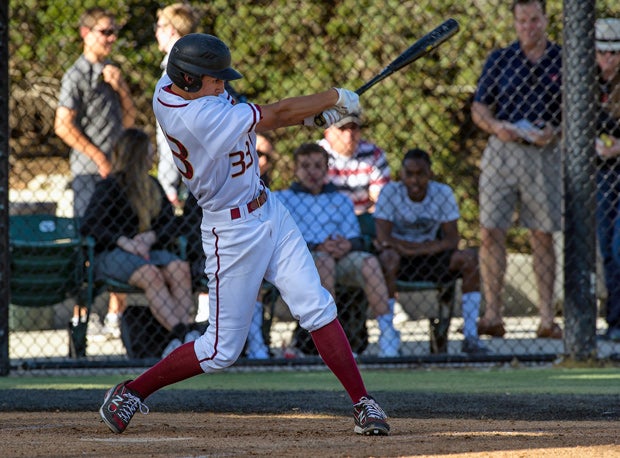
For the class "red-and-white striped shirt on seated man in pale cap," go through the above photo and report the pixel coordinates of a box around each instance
[318,139,390,214]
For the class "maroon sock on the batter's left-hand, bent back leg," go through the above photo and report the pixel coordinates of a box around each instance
[127,342,204,400]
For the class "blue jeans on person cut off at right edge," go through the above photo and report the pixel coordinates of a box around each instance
[596,166,620,329]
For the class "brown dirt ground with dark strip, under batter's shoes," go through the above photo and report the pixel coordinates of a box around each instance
[0,390,620,458]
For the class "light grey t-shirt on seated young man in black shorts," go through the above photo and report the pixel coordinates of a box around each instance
[374,180,460,242]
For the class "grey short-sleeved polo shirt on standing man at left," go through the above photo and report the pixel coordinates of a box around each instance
[58,55,123,176]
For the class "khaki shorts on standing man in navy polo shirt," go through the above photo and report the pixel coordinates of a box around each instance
[479,136,562,232]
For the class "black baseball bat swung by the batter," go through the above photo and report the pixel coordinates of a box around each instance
[355,18,459,95]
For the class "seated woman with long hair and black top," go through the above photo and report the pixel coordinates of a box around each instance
[80,128,200,357]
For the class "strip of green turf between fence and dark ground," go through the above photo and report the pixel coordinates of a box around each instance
[0,367,620,395]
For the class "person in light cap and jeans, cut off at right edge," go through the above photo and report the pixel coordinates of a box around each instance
[595,18,620,342]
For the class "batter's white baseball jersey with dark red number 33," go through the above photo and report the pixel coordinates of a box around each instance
[153,75,261,212]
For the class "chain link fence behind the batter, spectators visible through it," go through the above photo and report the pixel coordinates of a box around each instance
[0,0,620,369]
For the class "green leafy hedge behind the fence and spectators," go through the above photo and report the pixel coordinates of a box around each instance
[9,0,620,250]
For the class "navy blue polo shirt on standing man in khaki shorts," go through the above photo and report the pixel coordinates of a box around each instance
[474,41,562,126]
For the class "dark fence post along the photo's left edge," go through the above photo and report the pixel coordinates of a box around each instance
[0,2,10,375]
